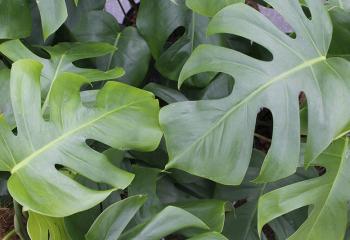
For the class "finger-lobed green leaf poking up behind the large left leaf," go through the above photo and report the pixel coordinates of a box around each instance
[0,40,124,110]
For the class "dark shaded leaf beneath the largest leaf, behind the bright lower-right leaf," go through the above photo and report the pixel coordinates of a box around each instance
[214,150,317,240]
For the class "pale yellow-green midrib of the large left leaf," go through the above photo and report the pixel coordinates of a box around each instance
[11,99,149,174]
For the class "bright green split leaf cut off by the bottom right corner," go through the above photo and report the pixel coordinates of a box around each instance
[258,138,350,240]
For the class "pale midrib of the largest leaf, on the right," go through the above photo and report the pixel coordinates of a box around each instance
[165,56,327,165]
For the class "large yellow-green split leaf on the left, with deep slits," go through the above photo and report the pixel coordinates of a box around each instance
[0,60,161,217]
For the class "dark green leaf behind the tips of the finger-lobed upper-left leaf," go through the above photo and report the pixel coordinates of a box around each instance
[67,6,151,86]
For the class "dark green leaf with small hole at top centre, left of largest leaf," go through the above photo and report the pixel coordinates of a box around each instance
[136,0,223,86]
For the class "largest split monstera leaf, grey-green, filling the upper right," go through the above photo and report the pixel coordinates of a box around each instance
[160,0,350,185]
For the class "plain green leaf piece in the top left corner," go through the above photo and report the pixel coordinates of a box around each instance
[0,0,32,39]
